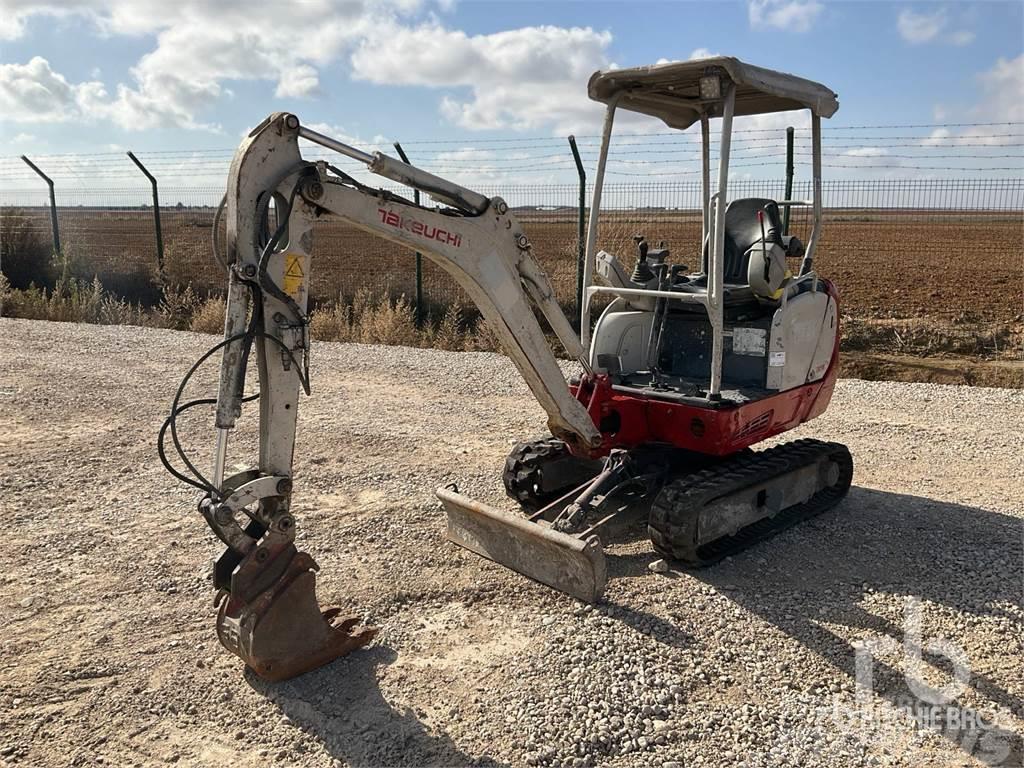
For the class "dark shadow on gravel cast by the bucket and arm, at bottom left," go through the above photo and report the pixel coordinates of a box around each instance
[246,645,504,768]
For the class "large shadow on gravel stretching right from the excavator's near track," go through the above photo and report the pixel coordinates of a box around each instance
[663,487,1024,766]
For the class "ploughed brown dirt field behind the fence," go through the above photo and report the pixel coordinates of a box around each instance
[14,208,1024,325]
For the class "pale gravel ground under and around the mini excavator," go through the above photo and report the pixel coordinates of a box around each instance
[0,319,1024,768]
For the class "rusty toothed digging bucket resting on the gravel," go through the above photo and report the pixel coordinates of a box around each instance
[217,545,377,681]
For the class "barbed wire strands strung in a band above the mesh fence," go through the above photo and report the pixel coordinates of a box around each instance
[0,122,1024,186]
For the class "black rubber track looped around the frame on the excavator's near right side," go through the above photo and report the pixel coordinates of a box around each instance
[647,439,853,567]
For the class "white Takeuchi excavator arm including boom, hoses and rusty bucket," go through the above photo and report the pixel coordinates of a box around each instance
[161,113,601,680]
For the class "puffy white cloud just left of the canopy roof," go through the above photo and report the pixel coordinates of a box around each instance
[351,24,611,132]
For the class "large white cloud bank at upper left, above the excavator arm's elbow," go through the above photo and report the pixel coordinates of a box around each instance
[0,0,419,130]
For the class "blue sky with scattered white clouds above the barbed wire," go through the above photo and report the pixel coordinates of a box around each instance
[0,0,1024,190]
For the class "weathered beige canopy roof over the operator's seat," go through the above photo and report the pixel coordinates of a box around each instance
[587,56,839,130]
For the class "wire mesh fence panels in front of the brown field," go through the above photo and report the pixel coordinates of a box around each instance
[0,178,1024,323]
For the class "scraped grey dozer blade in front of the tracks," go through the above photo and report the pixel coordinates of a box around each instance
[437,488,607,603]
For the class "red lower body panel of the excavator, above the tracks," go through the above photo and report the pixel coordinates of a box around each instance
[569,281,839,456]
